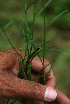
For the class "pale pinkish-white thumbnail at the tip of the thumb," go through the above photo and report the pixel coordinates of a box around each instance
[44,87,57,101]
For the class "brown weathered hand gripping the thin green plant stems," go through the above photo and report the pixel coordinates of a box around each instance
[0,49,57,104]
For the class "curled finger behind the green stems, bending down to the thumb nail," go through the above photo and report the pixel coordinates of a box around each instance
[32,56,56,88]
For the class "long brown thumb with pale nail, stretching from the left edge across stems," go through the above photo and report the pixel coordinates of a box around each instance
[0,74,57,102]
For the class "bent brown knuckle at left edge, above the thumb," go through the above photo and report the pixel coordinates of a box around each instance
[0,48,25,76]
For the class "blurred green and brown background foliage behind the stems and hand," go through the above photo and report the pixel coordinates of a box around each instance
[0,0,70,103]
